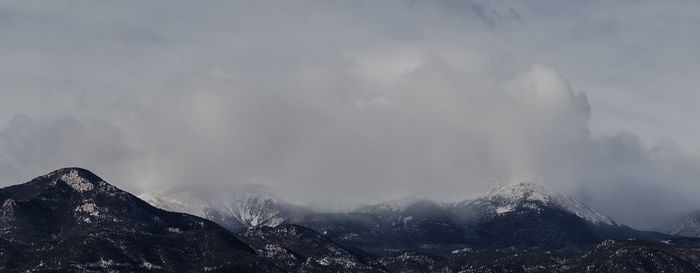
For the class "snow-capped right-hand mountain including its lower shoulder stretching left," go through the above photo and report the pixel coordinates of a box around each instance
[295,183,667,255]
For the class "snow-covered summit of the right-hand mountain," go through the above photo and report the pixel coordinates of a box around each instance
[470,182,616,225]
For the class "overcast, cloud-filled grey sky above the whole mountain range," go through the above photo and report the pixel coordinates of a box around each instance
[0,0,700,228]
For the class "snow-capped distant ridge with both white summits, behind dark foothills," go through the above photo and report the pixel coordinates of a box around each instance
[142,183,667,255]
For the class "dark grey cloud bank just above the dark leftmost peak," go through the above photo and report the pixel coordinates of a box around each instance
[0,115,138,185]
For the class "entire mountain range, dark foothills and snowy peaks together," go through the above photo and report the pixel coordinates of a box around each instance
[0,168,700,272]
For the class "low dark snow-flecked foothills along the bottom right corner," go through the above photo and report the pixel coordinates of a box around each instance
[412,239,700,273]
